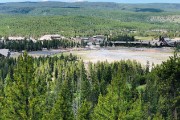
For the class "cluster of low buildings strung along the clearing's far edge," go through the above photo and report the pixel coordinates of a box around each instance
[0,34,180,57]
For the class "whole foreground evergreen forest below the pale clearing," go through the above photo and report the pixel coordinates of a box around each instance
[0,52,180,120]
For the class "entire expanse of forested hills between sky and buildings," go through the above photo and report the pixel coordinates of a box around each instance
[0,2,180,38]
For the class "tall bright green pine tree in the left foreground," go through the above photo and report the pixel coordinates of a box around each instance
[3,52,38,120]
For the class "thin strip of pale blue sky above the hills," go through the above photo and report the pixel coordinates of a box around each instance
[0,0,180,3]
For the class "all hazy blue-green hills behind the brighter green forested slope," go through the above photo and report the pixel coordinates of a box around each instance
[0,2,180,22]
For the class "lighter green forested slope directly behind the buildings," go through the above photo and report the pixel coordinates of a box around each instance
[0,15,180,39]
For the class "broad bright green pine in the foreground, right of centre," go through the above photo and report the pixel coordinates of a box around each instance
[92,75,127,120]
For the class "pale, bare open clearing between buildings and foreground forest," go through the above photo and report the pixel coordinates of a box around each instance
[61,47,173,65]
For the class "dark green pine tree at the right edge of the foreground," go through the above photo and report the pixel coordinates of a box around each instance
[156,53,180,120]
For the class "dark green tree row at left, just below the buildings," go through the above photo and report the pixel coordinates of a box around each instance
[0,40,85,51]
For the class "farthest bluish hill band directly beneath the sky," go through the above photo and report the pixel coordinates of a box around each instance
[0,2,180,15]
